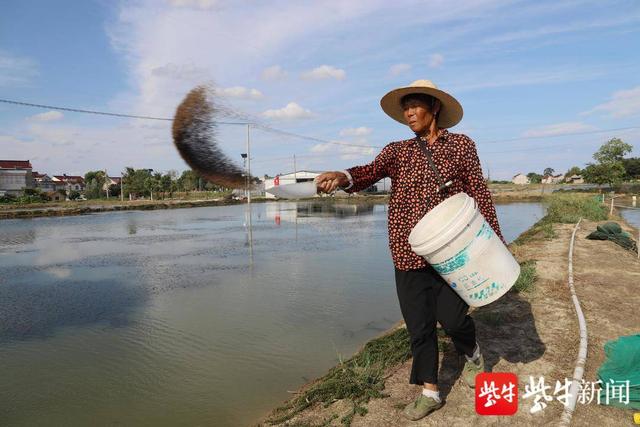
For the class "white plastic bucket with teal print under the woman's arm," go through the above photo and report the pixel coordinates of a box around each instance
[409,193,520,307]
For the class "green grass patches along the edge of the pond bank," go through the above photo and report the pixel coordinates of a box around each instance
[264,194,607,426]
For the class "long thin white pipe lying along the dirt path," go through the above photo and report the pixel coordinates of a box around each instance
[560,218,587,426]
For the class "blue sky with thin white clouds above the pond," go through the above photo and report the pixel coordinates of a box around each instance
[0,0,640,179]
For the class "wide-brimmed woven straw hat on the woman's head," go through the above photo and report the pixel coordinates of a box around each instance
[380,80,462,128]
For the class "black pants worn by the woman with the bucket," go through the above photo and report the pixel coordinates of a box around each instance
[396,266,476,385]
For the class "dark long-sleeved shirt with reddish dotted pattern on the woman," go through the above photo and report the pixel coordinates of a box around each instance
[346,130,506,271]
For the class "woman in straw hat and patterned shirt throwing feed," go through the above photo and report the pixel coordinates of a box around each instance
[316,80,506,420]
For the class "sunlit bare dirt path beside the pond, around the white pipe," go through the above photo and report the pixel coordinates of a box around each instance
[264,218,640,426]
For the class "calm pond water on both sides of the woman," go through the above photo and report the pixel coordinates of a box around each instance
[0,202,544,426]
